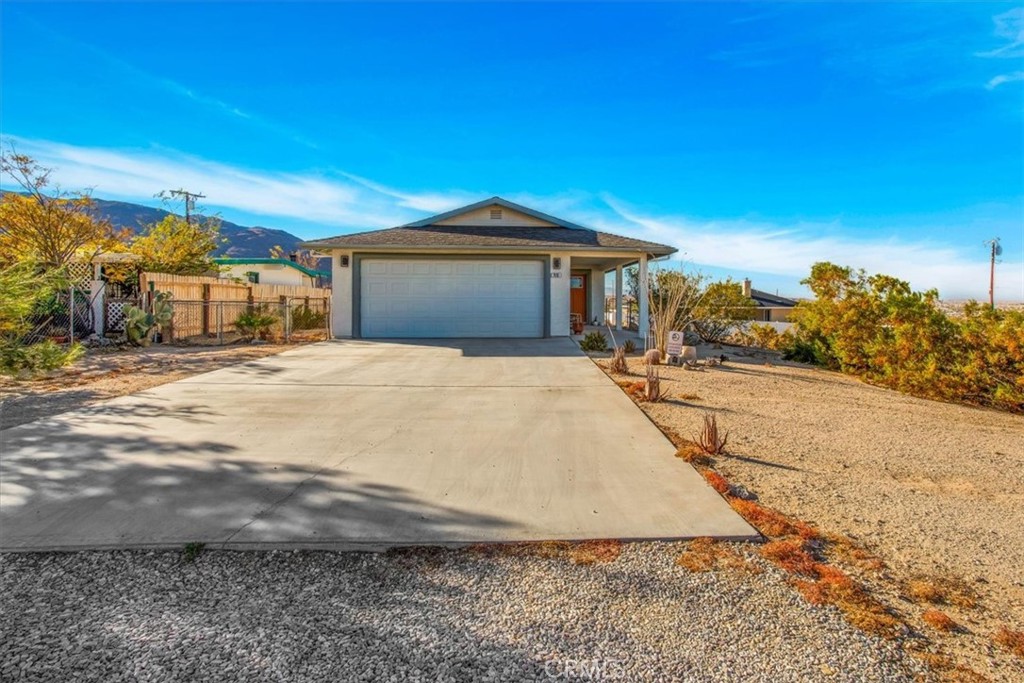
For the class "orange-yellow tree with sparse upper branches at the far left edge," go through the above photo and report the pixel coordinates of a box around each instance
[0,147,124,268]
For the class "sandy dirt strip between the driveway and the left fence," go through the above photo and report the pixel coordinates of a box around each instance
[0,344,295,429]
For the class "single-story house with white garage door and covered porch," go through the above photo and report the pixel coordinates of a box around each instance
[303,197,676,338]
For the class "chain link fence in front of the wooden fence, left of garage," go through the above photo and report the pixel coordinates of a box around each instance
[158,297,331,346]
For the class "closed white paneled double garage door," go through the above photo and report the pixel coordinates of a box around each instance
[359,259,544,338]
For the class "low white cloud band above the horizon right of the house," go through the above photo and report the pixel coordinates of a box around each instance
[603,195,1024,300]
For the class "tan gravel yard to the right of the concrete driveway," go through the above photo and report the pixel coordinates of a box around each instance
[602,347,1024,681]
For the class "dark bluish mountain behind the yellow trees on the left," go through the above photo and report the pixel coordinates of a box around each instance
[93,199,315,258]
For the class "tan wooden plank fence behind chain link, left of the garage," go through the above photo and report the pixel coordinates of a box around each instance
[139,272,331,341]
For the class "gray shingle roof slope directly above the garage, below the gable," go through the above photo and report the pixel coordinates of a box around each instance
[305,225,676,256]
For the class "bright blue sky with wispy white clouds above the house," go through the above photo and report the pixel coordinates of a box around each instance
[0,2,1024,301]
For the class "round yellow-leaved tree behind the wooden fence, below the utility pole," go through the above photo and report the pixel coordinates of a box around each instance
[130,214,223,275]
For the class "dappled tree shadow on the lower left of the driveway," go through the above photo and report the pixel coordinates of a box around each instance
[0,395,508,550]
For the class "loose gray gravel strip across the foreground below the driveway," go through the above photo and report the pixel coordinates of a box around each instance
[0,544,922,681]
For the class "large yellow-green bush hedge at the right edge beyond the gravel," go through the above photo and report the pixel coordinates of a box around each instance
[787,262,1024,411]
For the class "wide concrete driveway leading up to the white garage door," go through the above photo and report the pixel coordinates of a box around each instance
[0,339,755,550]
